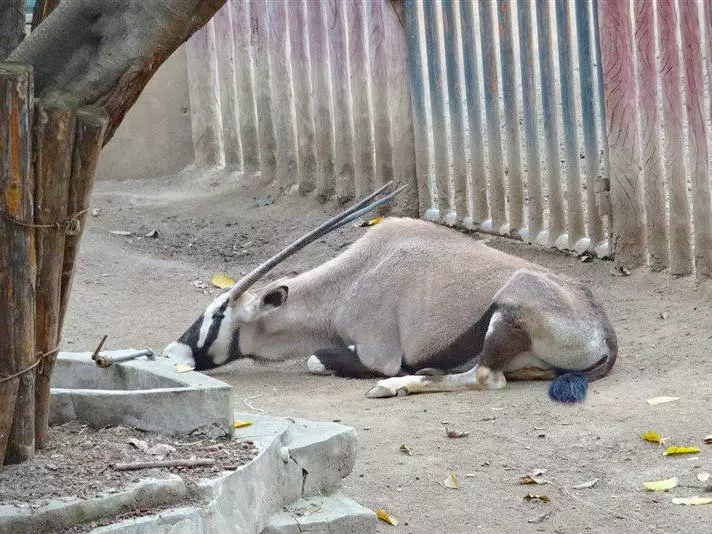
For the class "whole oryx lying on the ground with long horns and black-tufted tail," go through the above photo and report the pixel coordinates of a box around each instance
[164,183,618,402]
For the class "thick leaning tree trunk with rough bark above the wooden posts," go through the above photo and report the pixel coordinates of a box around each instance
[8,0,225,144]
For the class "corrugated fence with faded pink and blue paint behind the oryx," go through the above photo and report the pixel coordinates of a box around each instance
[188,0,712,277]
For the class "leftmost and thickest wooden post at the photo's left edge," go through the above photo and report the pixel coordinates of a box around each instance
[0,64,37,467]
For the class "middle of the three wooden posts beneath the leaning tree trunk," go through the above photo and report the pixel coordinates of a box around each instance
[34,92,77,448]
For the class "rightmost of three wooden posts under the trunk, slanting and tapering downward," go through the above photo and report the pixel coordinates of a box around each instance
[57,106,109,336]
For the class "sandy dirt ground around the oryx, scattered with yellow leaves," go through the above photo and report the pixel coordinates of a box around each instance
[62,175,712,534]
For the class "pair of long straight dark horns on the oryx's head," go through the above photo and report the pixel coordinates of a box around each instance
[230,182,408,303]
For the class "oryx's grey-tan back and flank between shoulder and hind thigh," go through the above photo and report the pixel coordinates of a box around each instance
[342,218,541,363]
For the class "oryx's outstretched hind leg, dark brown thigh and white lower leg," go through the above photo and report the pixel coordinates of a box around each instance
[366,308,531,398]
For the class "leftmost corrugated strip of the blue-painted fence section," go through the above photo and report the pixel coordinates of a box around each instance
[405,0,433,218]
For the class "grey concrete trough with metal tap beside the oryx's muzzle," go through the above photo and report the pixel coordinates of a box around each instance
[49,350,234,437]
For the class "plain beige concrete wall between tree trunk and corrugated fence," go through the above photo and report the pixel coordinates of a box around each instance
[97,45,195,180]
